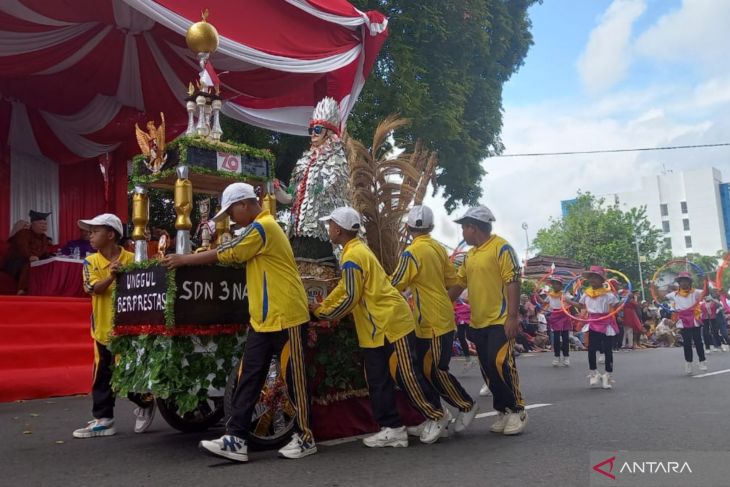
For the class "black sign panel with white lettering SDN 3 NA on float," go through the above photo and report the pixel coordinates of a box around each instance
[175,266,249,325]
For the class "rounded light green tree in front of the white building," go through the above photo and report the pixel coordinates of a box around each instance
[533,193,670,290]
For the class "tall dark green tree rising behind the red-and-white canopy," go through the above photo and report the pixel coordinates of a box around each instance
[219,0,538,210]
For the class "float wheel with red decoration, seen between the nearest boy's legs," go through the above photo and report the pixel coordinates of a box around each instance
[223,358,296,448]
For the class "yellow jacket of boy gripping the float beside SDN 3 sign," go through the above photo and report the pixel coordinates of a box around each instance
[218,210,309,333]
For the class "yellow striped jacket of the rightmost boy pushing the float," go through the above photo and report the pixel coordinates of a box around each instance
[457,235,520,328]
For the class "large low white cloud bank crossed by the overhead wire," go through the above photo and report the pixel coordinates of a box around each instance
[425,87,730,264]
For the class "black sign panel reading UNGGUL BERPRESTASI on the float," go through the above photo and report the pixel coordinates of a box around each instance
[114,266,167,326]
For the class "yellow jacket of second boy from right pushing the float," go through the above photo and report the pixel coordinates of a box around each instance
[391,235,458,338]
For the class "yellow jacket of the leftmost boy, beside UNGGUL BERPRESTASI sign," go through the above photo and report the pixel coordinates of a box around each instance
[83,249,134,345]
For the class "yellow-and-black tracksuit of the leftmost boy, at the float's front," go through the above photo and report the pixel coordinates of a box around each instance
[83,249,151,419]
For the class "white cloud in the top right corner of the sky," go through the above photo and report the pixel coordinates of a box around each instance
[636,0,730,73]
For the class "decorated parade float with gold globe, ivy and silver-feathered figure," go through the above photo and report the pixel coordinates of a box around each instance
[111,12,436,446]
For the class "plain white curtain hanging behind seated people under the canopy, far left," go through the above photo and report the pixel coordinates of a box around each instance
[10,150,59,243]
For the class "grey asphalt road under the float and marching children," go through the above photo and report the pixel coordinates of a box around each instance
[0,348,730,487]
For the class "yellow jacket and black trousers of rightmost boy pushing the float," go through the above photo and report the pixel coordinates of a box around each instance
[457,235,525,412]
